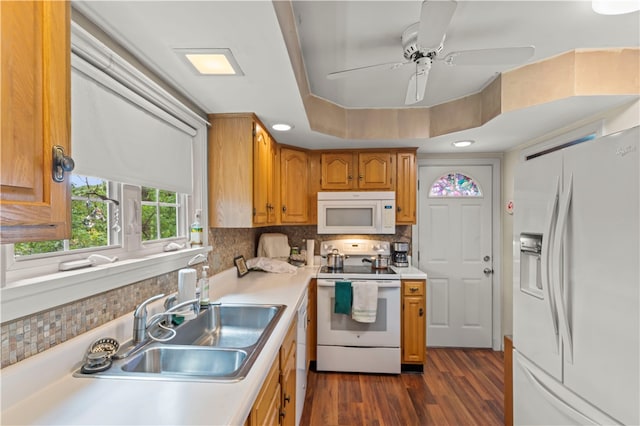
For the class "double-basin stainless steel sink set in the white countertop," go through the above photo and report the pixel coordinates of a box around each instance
[74,304,286,382]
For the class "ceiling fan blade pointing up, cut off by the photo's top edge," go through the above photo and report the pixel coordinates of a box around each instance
[418,0,458,50]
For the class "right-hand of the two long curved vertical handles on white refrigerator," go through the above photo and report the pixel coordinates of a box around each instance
[553,174,573,364]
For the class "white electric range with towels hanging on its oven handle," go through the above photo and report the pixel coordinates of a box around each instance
[316,239,401,374]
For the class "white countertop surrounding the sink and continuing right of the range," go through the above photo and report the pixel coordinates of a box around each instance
[0,267,427,425]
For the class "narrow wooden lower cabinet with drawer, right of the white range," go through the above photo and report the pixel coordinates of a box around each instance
[401,280,427,370]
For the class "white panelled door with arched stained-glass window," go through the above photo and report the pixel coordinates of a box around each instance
[418,165,493,347]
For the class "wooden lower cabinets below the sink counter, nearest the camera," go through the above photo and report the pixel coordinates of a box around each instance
[245,321,298,426]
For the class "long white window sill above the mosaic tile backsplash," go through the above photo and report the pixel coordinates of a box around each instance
[0,247,211,323]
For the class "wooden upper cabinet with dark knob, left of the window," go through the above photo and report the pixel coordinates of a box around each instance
[0,1,71,243]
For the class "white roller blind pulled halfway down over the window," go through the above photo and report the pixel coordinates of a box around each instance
[71,55,197,194]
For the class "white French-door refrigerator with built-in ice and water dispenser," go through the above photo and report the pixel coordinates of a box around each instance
[513,127,640,425]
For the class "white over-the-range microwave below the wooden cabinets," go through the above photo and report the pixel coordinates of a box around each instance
[318,191,396,234]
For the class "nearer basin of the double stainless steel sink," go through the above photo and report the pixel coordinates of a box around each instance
[122,345,247,378]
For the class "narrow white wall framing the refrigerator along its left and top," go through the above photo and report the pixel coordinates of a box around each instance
[502,100,640,335]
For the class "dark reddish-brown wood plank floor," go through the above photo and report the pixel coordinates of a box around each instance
[300,348,504,426]
